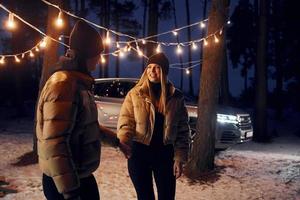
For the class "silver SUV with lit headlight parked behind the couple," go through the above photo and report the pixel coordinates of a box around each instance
[94,78,253,149]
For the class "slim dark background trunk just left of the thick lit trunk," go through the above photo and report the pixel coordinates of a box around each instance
[185,0,194,96]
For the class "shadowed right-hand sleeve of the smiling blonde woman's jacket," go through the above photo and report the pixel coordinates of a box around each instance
[174,98,190,163]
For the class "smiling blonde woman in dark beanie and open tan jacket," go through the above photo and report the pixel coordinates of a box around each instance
[117,53,190,200]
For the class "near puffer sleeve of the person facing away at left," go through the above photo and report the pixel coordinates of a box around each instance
[39,82,79,193]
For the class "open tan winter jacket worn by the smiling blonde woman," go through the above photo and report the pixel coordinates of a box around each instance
[117,73,190,162]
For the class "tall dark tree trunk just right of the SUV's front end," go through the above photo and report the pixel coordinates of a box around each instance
[253,0,268,142]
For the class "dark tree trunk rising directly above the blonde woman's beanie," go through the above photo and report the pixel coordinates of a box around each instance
[147,0,158,57]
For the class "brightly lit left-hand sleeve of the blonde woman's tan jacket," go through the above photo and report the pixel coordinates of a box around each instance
[117,92,135,144]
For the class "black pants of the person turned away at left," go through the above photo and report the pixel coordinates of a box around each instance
[43,174,100,200]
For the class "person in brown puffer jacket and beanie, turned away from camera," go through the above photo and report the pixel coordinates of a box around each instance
[36,20,126,200]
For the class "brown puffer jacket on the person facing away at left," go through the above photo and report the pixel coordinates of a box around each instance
[36,71,101,193]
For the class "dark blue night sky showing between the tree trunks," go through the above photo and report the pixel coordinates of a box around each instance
[0,0,270,96]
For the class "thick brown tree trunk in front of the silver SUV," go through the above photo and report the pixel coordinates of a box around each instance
[186,0,228,179]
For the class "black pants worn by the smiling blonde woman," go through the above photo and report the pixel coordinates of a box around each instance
[128,142,176,200]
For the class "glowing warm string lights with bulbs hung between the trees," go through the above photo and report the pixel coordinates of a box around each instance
[0,0,230,74]
